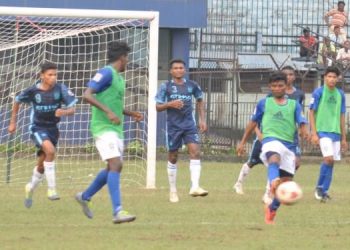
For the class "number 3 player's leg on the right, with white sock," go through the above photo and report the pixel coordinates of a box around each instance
[183,132,209,197]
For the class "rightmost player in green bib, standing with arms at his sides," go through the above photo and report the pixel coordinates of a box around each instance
[309,67,348,202]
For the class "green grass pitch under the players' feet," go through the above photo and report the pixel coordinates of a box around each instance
[0,162,350,250]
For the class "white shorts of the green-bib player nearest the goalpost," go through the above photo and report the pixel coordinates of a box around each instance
[95,132,124,161]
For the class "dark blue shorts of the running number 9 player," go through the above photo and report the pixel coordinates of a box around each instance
[30,127,60,149]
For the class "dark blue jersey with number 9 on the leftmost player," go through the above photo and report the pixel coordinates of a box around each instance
[16,83,78,128]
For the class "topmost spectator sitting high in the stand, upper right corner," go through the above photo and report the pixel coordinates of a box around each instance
[324,1,348,41]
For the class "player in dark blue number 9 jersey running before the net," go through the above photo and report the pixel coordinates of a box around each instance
[8,62,77,208]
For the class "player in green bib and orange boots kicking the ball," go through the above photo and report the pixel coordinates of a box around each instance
[237,72,308,224]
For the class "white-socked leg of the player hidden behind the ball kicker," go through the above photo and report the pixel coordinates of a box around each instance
[233,139,262,194]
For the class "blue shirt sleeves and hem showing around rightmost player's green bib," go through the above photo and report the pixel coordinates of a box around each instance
[309,86,346,141]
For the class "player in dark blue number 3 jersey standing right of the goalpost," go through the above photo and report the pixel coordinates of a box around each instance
[156,59,208,202]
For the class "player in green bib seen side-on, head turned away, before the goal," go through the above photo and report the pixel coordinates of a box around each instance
[75,42,143,224]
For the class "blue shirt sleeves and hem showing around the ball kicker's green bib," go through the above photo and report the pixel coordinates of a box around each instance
[252,98,307,152]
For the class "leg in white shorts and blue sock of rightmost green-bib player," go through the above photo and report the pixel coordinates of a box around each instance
[315,137,334,201]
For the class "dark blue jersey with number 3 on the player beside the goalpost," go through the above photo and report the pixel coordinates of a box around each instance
[156,80,203,130]
